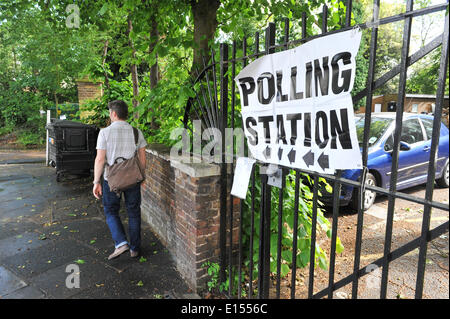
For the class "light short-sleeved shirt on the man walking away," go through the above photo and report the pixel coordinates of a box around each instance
[97,121,147,180]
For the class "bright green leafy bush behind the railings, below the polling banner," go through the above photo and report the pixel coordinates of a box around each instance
[202,174,344,294]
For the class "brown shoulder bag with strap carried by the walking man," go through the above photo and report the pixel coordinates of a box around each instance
[108,127,145,194]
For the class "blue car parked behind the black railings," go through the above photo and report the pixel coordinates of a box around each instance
[322,112,449,210]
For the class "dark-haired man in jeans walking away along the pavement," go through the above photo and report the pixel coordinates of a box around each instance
[92,100,147,259]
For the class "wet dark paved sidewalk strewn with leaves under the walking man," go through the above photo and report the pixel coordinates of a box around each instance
[0,159,195,299]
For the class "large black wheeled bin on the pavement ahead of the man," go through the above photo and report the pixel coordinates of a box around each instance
[46,120,100,182]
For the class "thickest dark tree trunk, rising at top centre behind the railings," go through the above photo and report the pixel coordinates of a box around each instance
[190,0,220,75]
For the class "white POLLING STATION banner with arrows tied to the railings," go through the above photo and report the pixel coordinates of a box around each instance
[235,30,362,173]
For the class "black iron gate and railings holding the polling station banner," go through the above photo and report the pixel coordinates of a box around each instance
[184,0,449,298]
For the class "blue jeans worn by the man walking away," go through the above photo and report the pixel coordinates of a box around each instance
[102,181,141,251]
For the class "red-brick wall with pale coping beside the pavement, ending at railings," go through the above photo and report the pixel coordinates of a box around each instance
[141,144,240,291]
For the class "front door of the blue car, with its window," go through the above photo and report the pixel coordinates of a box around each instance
[397,118,430,189]
